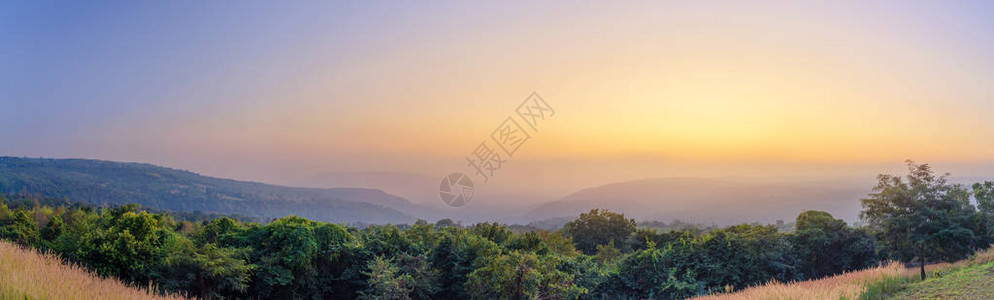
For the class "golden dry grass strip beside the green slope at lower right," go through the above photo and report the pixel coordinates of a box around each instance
[694,263,914,300]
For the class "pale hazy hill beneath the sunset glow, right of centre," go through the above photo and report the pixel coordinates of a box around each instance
[528,178,870,225]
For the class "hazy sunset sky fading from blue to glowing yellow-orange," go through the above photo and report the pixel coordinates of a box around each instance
[0,1,994,200]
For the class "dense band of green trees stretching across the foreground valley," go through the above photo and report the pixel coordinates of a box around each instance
[0,162,994,299]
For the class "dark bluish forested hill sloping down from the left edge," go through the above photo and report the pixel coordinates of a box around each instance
[0,157,414,223]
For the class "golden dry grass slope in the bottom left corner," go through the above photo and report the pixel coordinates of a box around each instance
[0,241,182,300]
